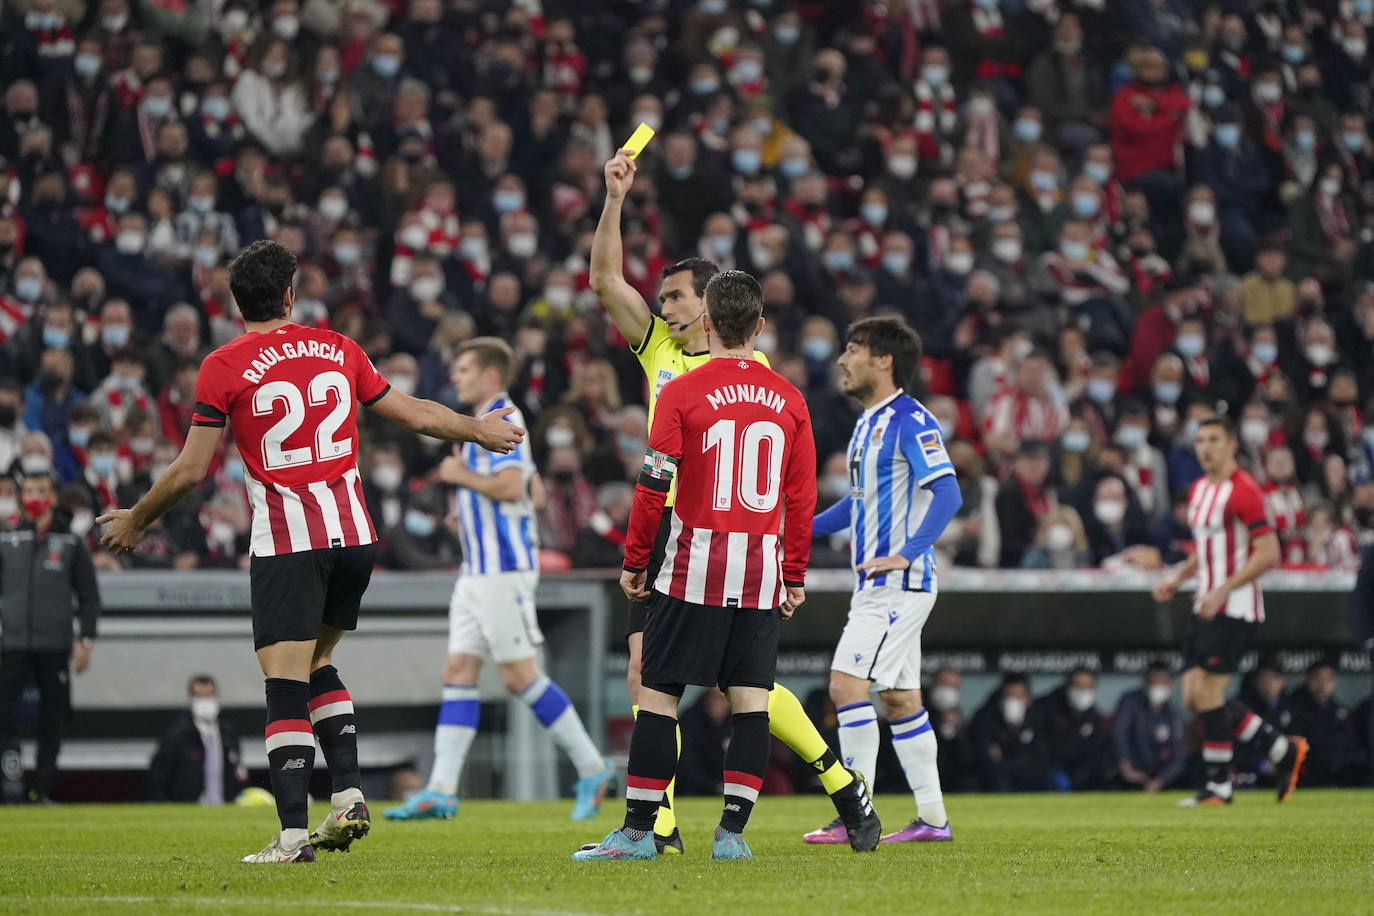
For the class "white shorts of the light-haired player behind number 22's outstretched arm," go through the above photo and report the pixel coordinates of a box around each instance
[448,570,544,662]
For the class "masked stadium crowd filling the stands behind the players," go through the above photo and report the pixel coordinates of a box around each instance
[0,0,1374,569]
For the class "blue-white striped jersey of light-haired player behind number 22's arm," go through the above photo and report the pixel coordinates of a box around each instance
[453,391,539,575]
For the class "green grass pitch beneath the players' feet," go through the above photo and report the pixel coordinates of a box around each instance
[0,790,1374,916]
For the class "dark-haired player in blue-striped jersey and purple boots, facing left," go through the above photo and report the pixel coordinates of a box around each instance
[805,317,962,843]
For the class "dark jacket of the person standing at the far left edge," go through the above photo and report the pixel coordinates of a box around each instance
[0,527,100,652]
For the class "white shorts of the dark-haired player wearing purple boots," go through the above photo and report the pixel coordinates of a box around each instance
[830,588,936,691]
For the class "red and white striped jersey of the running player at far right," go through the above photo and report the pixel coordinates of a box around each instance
[1189,468,1274,623]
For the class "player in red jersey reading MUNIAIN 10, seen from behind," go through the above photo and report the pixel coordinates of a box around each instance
[573,271,816,861]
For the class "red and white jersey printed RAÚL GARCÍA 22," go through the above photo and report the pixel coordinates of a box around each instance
[191,324,390,556]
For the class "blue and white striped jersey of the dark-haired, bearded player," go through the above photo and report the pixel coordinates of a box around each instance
[849,390,954,592]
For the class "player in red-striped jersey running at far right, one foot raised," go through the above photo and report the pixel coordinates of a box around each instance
[1154,416,1307,806]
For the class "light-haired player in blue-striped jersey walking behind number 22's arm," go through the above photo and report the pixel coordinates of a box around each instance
[386,338,616,820]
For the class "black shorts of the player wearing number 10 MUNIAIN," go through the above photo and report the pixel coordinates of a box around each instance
[640,592,779,696]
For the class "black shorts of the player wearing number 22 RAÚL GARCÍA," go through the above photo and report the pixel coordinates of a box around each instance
[249,544,376,650]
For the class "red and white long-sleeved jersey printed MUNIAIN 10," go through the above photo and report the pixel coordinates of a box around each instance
[625,358,816,608]
